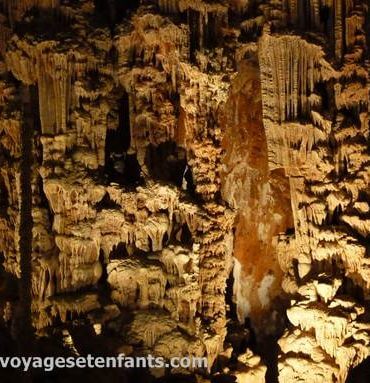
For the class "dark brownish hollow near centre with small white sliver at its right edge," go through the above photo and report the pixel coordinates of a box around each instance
[145,141,190,187]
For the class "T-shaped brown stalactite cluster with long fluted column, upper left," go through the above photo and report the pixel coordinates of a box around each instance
[6,37,105,134]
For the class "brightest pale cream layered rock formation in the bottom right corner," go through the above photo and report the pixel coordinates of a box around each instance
[279,280,370,382]
